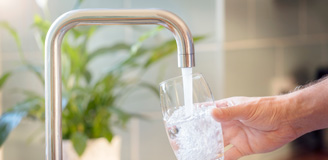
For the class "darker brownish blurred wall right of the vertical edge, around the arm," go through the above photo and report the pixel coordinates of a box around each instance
[224,0,328,159]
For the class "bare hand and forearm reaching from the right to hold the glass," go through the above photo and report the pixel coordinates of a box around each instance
[212,79,328,160]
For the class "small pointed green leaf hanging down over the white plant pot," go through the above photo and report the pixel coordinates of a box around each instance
[71,132,88,156]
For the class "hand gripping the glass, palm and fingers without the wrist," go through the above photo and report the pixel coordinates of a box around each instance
[212,96,299,160]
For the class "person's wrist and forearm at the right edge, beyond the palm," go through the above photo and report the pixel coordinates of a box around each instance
[286,82,328,136]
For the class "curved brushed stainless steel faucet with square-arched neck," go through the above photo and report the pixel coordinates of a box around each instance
[44,9,195,160]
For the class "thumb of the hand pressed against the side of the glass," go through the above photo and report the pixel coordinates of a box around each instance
[212,105,250,122]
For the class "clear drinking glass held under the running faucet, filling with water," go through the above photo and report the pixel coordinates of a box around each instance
[160,74,224,160]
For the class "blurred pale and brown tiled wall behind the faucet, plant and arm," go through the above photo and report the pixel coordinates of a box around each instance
[0,0,328,160]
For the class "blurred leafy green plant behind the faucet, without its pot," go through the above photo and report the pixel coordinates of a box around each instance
[0,0,204,155]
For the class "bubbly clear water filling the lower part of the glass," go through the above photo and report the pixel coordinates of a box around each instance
[165,106,223,160]
